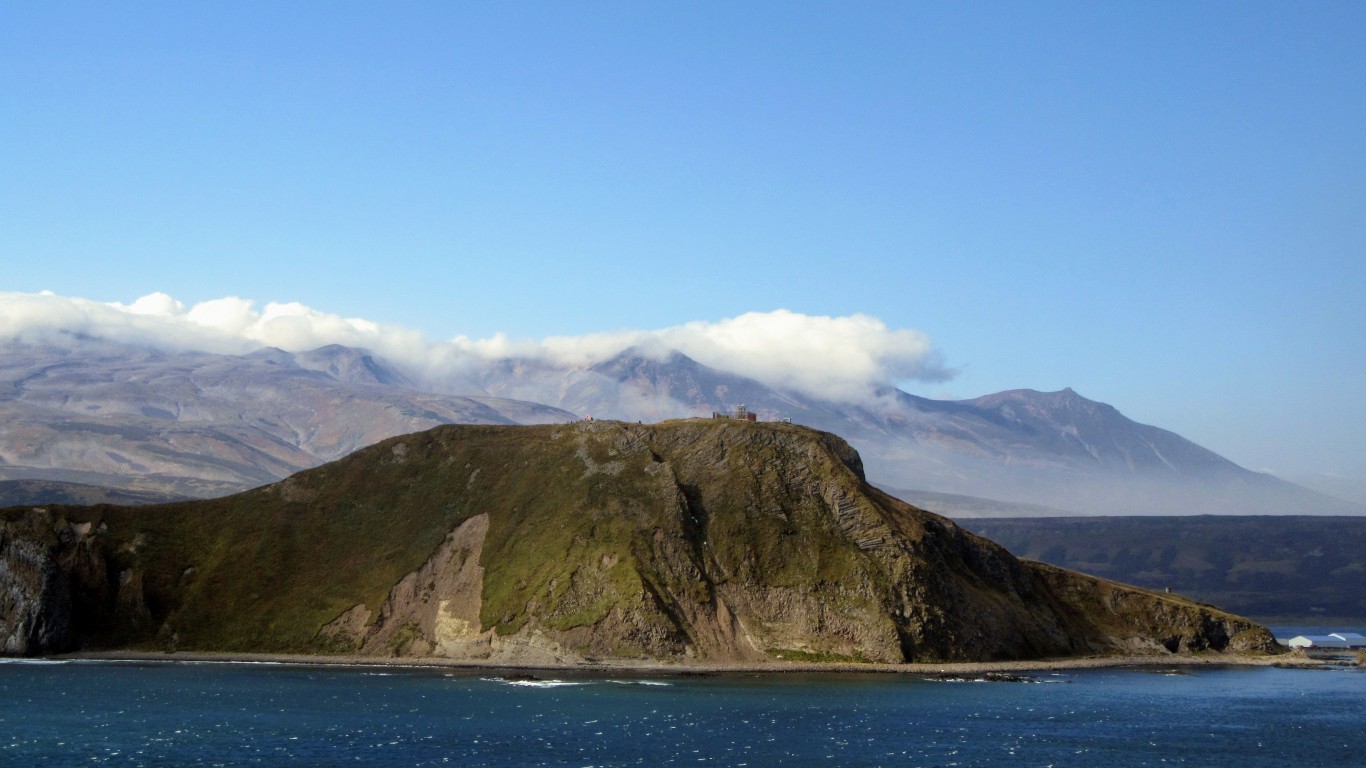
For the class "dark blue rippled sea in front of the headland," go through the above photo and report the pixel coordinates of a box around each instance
[0,647,1366,768]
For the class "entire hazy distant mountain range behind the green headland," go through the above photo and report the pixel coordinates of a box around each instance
[0,335,1366,517]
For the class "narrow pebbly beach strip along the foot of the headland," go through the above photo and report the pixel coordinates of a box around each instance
[45,650,1343,676]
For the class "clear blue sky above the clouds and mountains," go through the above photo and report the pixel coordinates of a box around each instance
[0,0,1366,497]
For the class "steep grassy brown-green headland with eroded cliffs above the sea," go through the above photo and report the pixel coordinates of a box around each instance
[0,420,1274,664]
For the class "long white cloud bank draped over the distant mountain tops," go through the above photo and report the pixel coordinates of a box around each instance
[0,292,953,400]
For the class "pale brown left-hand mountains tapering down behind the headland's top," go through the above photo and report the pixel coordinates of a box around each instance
[0,338,576,497]
